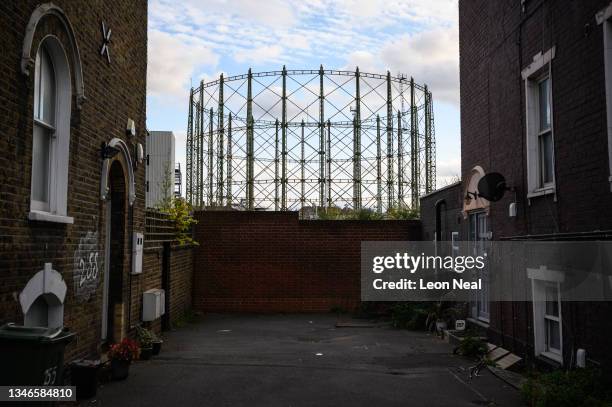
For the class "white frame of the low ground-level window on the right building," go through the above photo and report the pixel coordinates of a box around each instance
[527,266,565,364]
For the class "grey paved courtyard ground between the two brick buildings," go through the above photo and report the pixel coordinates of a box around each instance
[88,314,521,407]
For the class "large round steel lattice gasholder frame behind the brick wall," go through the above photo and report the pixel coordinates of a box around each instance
[186,66,436,212]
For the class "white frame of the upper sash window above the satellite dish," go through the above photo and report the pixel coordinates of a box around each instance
[521,47,556,198]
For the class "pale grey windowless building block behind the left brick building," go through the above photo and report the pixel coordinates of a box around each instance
[145,131,175,208]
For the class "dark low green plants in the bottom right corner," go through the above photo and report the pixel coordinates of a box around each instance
[521,368,612,407]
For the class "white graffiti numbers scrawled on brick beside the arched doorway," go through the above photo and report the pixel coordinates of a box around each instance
[74,232,101,301]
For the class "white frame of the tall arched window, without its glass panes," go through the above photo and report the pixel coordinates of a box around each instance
[28,35,74,223]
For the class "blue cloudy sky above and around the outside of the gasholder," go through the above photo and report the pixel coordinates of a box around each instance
[147,0,460,192]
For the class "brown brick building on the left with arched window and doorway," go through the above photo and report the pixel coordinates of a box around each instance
[0,0,191,360]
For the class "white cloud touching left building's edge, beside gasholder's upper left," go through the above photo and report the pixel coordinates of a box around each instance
[147,30,219,100]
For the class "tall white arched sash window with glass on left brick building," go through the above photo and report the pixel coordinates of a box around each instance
[30,36,73,223]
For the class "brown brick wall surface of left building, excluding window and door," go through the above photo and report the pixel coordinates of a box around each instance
[0,0,147,360]
